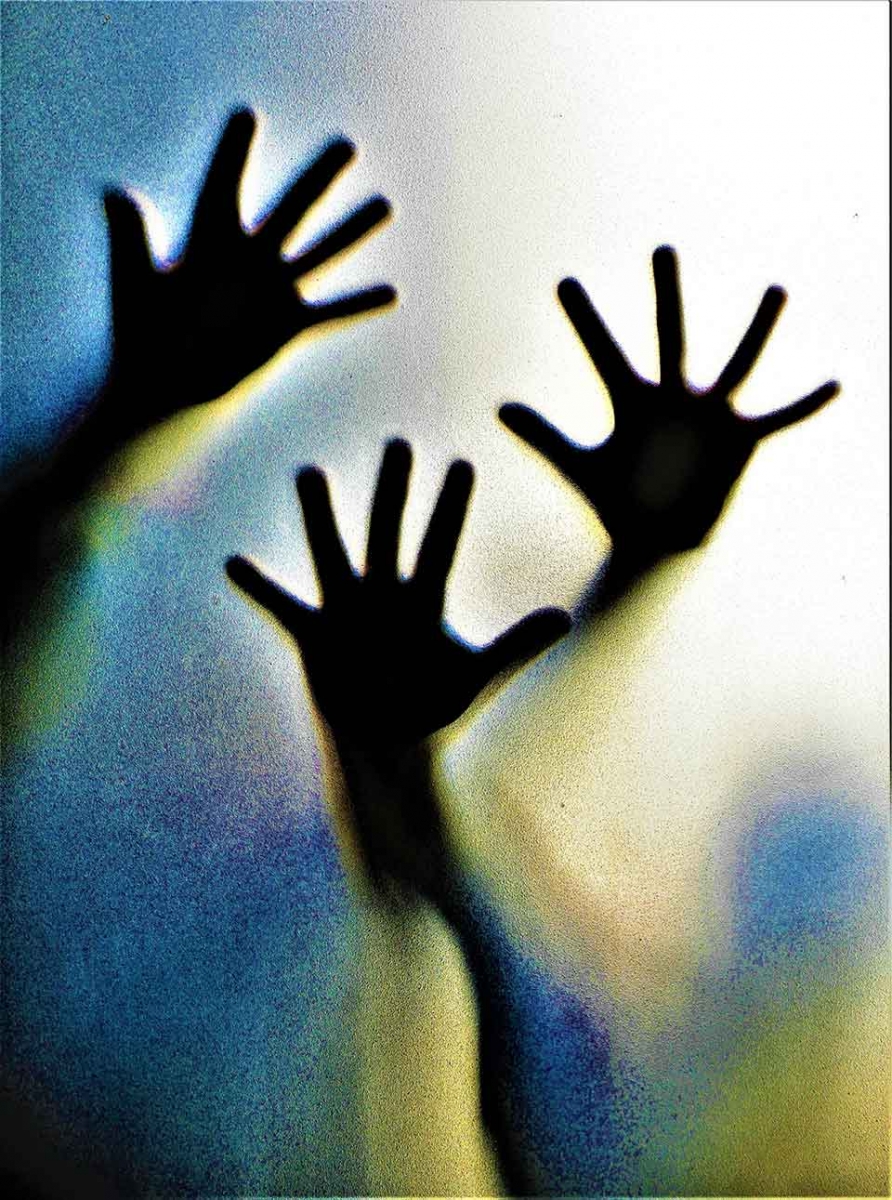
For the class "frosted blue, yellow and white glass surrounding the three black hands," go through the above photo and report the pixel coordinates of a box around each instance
[2,2,888,1194]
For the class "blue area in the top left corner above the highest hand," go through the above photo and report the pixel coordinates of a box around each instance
[2,4,391,467]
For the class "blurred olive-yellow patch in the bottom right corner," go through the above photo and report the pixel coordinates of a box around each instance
[687,964,890,1196]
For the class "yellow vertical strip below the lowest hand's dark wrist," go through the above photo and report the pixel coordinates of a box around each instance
[357,905,503,1196]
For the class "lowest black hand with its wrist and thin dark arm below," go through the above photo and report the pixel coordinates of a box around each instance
[227,440,570,1190]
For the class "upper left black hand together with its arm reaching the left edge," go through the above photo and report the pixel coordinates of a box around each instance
[4,110,395,648]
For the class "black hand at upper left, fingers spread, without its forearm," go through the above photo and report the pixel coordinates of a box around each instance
[106,110,395,428]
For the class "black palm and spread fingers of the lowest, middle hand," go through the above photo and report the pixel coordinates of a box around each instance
[227,440,570,748]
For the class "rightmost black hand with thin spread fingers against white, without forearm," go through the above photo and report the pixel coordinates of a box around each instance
[499,246,839,563]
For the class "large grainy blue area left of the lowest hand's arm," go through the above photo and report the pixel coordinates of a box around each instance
[6,489,361,1193]
